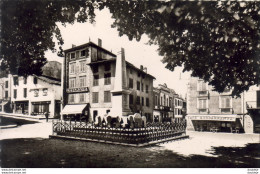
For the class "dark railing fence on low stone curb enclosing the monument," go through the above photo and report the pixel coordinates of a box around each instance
[50,121,188,147]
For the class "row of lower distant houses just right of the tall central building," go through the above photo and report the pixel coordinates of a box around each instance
[153,84,184,122]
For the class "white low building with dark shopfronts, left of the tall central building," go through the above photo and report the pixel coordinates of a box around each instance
[11,75,61,118]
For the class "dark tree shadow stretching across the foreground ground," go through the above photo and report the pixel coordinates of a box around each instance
[0,139,260,168]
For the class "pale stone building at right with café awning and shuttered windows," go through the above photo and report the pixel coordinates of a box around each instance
[186,77,259,133]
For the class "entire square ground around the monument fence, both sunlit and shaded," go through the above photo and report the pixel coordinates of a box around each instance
[0,115,260,168]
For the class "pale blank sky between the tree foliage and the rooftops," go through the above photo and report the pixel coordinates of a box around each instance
[45,9,190,98]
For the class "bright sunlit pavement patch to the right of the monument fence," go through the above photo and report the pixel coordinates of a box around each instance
[156,132,260,157]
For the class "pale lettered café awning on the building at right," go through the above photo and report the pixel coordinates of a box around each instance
[187,115,240,121]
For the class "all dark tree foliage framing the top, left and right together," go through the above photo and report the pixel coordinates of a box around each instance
[1,0,260,95]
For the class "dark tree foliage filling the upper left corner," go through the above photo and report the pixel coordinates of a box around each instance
[0,0,95,76]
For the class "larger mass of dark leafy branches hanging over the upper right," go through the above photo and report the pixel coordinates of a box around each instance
[106,1,260,96]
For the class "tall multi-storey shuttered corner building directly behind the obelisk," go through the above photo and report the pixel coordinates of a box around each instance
[62,39,155,122]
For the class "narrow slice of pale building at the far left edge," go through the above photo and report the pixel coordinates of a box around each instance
[0,75,12,112]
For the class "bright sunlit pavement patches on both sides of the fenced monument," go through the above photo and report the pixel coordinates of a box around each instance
[0,113,260,156]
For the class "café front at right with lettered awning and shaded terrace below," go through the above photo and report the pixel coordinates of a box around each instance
[188,115,243,133]
